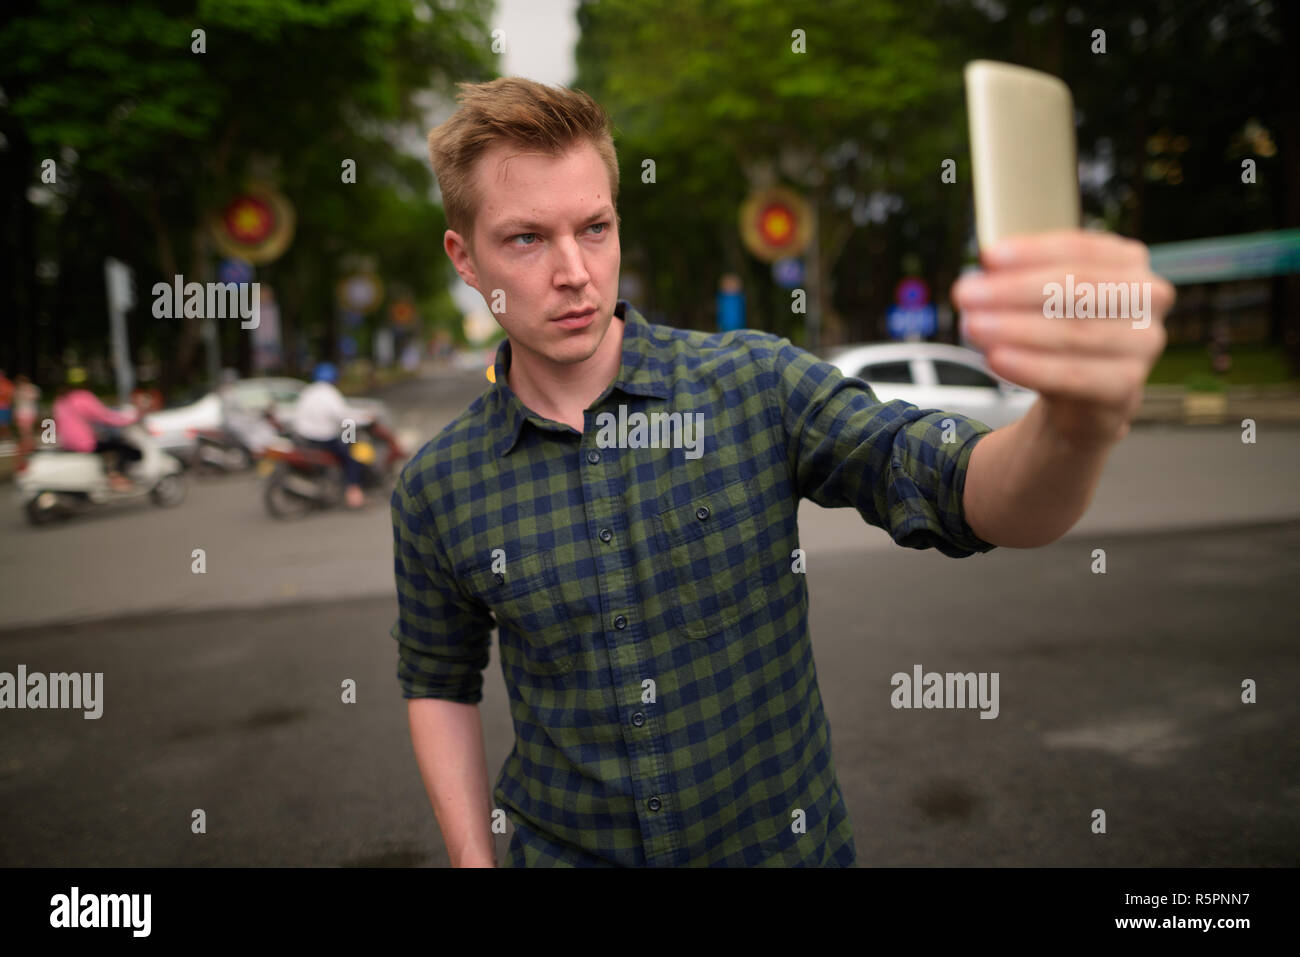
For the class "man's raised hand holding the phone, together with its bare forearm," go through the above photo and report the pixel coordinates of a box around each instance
[953,230,1174,549]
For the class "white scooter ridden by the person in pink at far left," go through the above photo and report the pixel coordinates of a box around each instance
[14,423,186,525]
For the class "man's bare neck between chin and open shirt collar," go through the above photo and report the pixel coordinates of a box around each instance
[506,316,624,432]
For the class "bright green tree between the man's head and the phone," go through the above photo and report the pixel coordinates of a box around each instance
[577,0,954,341]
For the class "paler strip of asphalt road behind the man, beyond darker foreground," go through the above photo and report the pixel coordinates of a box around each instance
[0,372,1300,628]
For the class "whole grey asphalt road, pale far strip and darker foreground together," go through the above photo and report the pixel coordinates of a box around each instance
[0,364,1300,866]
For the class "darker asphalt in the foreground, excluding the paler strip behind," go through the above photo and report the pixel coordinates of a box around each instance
[0,523,1300,866]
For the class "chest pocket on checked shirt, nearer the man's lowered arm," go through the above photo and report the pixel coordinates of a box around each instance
[465,550,577,675]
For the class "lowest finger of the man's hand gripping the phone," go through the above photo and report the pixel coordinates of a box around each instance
[985,346,1149,407]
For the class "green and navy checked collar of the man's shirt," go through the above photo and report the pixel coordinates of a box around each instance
[489,299,671,455]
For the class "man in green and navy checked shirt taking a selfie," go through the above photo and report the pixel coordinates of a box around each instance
[391,78,1173,867]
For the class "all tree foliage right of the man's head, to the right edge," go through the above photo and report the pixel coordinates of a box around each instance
[575,0,1300,351]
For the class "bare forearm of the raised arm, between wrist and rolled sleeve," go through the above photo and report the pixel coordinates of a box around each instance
[962,399,1114,549]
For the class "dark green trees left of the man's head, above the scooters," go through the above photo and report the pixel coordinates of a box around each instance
[0,0,493,390]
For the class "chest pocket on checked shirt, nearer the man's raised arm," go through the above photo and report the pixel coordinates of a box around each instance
[657,481,768,638]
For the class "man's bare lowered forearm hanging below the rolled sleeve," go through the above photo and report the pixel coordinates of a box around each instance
[407,698,497,867]
